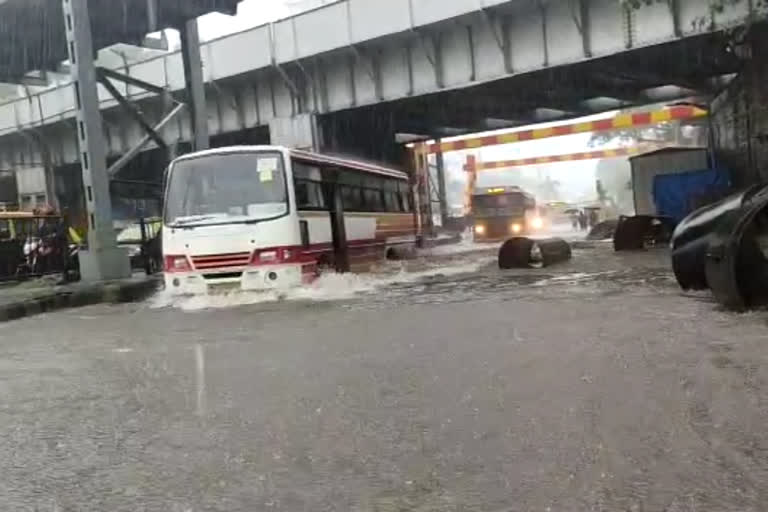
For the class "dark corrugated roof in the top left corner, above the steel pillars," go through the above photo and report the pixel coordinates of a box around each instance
[0,0,240,82]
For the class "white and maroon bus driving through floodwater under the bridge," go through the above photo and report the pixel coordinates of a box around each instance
[162,146,417,294]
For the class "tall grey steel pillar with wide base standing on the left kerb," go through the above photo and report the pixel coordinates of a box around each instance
[62,0,131,281]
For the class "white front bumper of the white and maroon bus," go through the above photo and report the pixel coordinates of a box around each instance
[165,263,317,295]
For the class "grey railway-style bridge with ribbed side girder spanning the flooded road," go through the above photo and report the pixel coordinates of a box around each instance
[0,0,763,172]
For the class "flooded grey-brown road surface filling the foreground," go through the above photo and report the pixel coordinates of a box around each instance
[0,244,768,512]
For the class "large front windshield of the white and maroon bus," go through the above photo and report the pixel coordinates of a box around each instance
[165,152,288,227]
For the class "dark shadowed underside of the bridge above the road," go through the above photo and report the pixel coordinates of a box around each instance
[320,34,742,166]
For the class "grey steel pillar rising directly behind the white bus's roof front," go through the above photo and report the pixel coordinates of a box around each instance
[180,19,211,151]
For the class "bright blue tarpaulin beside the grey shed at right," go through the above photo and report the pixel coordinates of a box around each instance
[653,169,730,222]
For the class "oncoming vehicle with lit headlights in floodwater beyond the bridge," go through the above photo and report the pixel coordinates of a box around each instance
[471,187,545,242]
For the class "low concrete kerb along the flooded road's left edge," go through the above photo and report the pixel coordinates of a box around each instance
[0,277,162,322]
